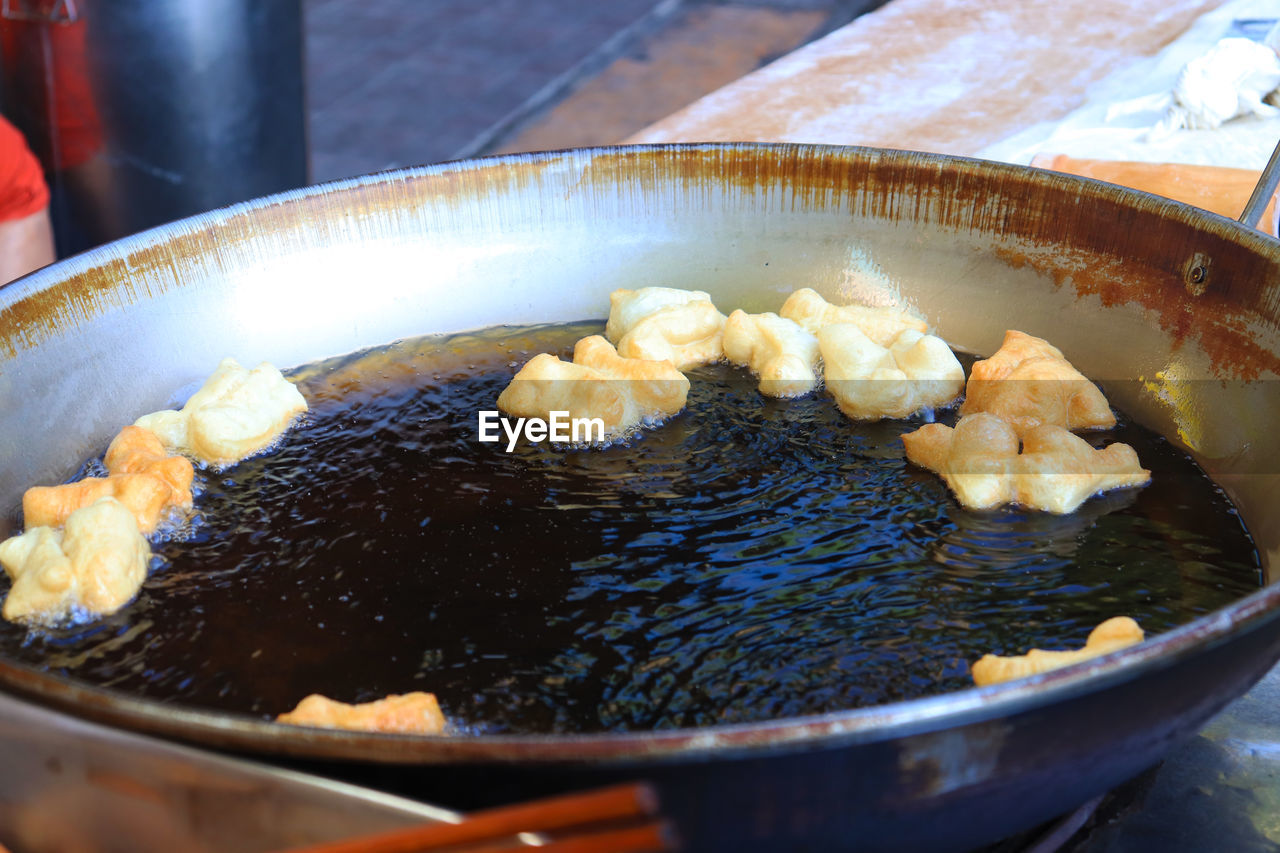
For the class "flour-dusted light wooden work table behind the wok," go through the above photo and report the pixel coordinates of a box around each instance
[626,0,1220,155]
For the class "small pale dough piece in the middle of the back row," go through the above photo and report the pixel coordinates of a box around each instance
[724,309,818,397]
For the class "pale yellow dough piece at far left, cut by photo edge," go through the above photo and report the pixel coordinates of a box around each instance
[0,497,151,625]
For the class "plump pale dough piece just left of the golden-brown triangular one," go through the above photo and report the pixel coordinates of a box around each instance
[818,323,964,420]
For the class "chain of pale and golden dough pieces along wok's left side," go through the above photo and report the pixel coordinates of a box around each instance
[0,359,306,625]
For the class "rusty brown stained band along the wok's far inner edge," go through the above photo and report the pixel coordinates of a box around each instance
[0,143,1280,371]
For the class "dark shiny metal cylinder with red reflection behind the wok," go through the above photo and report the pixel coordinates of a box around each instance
[0,0,307,255]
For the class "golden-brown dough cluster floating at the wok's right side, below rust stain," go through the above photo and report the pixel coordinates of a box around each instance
[902,326,1151,514]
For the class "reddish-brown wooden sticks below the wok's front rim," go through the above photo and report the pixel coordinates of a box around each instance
[279,784,663,853]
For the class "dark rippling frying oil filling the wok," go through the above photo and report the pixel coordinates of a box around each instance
[0,325,1260,731]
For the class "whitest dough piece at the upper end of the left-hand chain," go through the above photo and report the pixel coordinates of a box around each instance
[133,359,307,467]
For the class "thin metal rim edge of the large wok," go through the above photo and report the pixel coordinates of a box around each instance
[0,142,1280,763]
